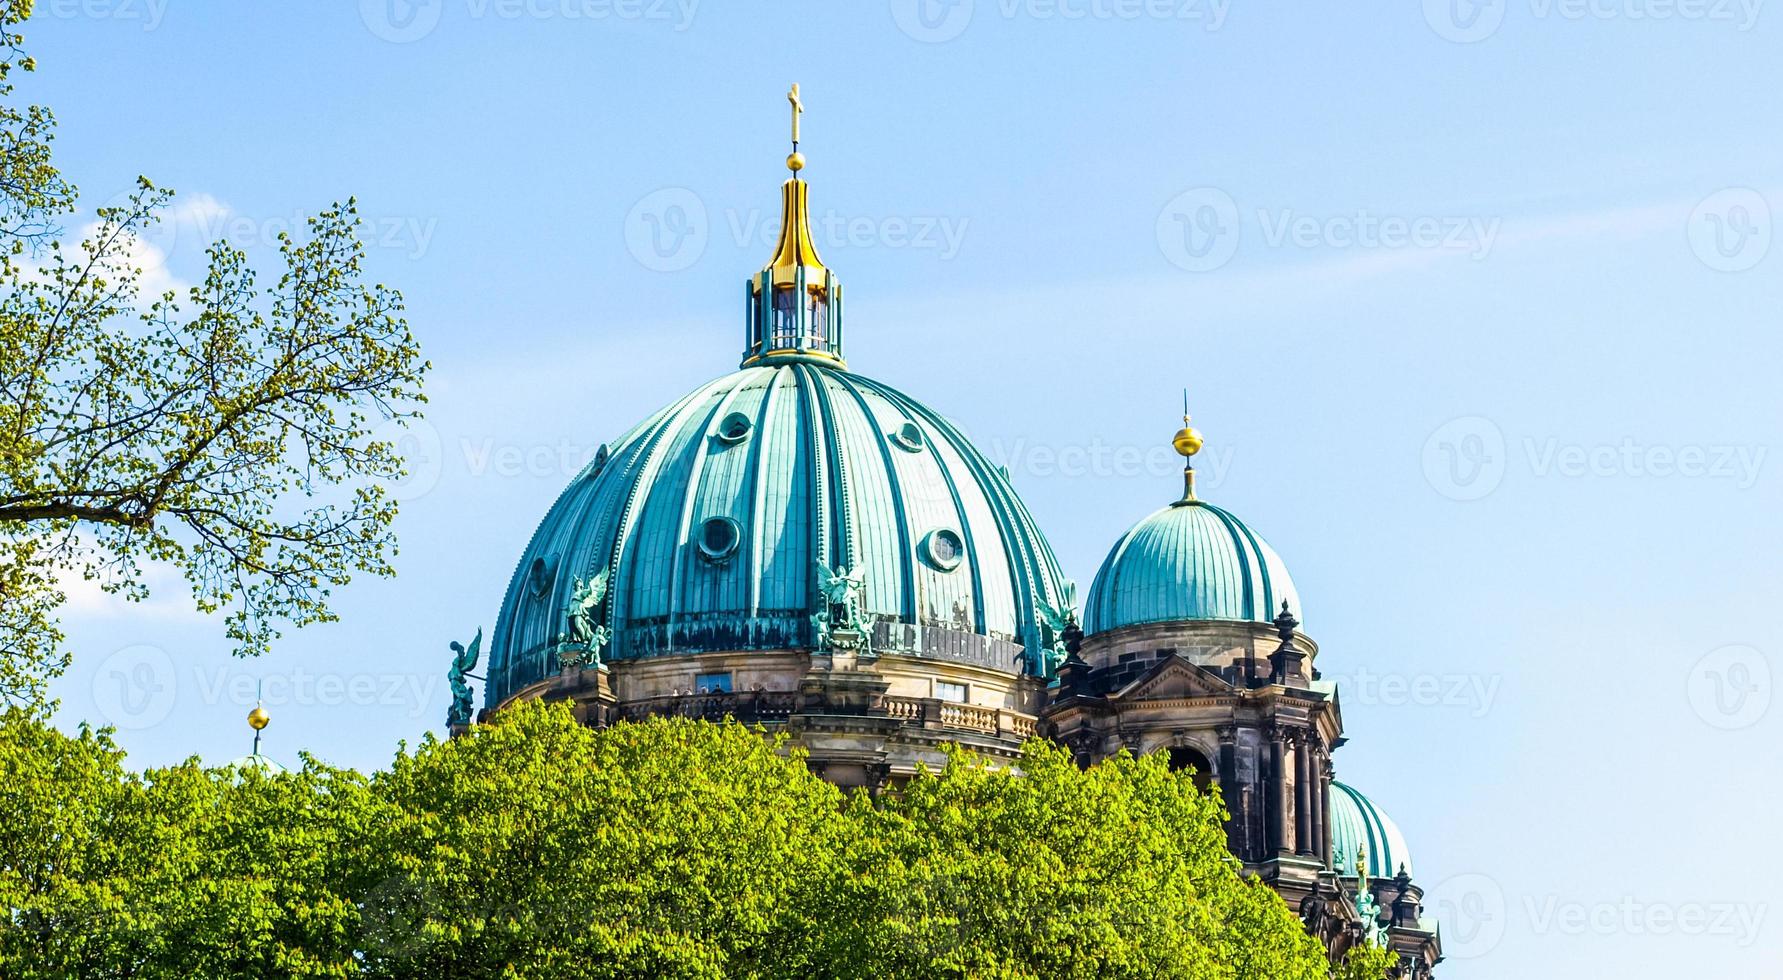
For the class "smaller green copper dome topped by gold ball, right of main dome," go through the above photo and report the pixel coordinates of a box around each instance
[1084,499,1303,633]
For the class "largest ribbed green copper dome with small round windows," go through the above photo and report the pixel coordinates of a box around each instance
[487,356,1064,704]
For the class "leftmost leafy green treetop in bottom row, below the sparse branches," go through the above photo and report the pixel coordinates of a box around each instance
[0,709,380,980]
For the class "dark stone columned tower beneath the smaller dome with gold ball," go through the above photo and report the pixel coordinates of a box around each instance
[1041,608,1442,980]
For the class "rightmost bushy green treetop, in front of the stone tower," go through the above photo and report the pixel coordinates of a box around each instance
[833,739,1325,980]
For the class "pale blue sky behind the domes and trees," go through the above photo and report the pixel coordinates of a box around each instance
[21,0,1783,980]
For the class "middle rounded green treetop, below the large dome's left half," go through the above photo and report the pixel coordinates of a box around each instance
[355,706,845,978]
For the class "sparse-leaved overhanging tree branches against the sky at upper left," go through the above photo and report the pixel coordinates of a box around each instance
[0,0,428,702]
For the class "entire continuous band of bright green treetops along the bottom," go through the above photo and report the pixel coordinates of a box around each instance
[0,704,1385,980]
